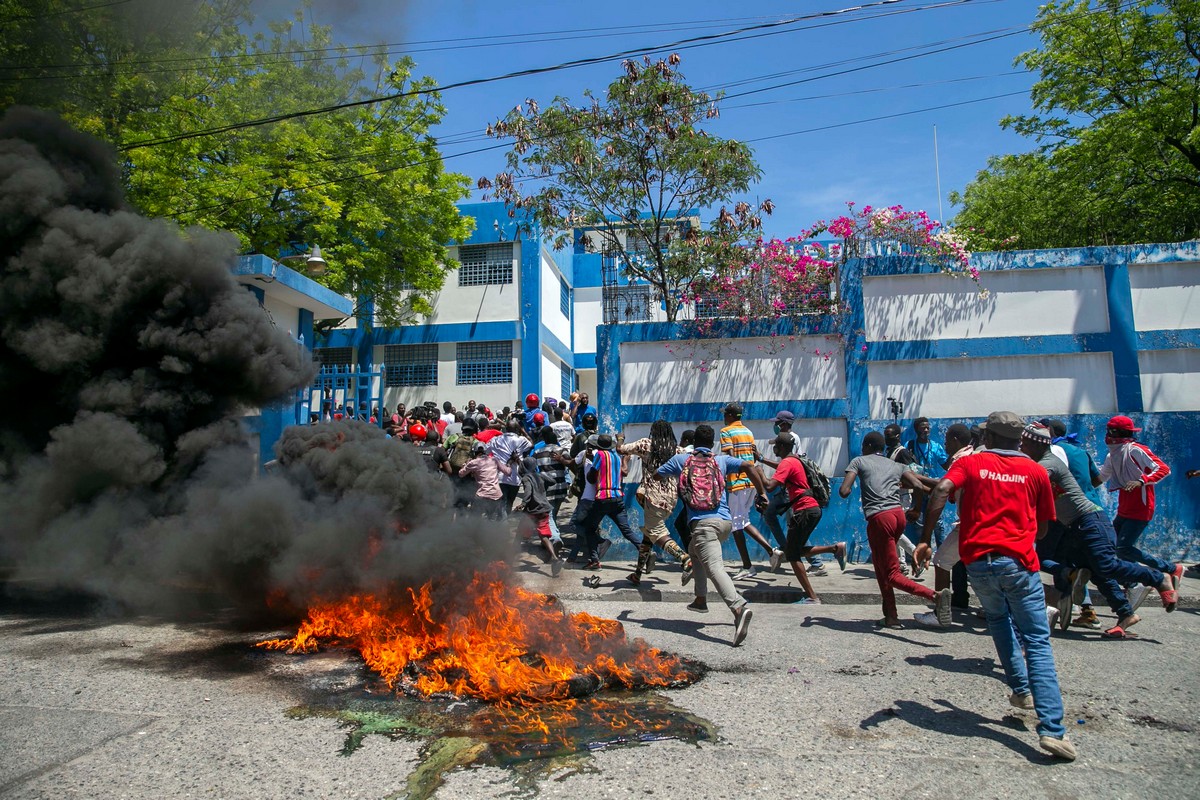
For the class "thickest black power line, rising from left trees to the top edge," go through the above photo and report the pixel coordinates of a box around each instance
[119,0,977,151]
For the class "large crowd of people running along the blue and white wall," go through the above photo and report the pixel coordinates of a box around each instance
[326,395,1200,760]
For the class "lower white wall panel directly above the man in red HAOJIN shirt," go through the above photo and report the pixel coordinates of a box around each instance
[868,353,1116,419]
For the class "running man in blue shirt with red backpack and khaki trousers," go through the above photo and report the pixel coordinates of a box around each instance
[658,425,767,646]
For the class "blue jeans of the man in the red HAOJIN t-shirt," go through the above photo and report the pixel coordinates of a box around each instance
[967,553,1067,739]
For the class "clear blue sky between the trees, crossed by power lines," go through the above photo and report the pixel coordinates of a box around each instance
[256,0,1038,236]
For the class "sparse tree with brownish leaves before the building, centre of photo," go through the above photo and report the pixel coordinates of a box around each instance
[479,55,773,320]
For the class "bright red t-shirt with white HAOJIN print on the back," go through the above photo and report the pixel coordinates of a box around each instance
[946,450,1055,572]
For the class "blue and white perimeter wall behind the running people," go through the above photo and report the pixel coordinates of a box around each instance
[598,242,1200,557]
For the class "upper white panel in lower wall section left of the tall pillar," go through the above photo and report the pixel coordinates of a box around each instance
[620,336,846,405]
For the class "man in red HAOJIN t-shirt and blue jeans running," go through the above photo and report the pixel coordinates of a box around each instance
[922,411,1075,760]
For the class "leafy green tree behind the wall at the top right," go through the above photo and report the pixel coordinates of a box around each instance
[950,0,1200,249]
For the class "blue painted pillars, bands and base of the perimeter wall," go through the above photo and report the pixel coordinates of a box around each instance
[592,243,1200,563]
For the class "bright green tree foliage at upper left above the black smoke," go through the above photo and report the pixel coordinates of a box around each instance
[0,0,472,325]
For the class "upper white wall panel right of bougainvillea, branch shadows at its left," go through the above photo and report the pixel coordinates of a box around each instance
[863,266,1109,342]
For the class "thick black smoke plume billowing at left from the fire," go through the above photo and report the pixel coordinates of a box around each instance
[0,109,500,612]
